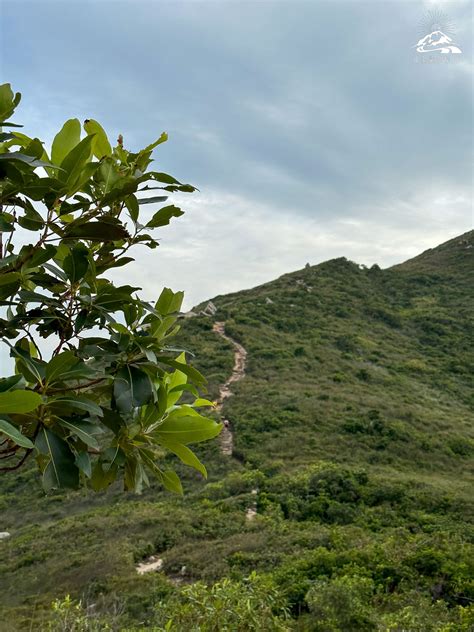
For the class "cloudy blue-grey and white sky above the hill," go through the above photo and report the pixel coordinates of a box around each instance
[0,0,473,308]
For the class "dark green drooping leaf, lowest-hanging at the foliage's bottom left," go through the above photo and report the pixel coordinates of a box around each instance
[36,428,79,491]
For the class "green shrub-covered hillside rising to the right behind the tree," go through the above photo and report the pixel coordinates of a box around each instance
[0,232,474,632]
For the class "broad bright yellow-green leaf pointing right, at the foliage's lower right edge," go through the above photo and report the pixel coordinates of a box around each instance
[152,406,222,445]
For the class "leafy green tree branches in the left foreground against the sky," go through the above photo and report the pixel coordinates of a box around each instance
[0,84,220,493]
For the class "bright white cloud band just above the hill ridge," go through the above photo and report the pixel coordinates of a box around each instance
[110,192,472,308]
